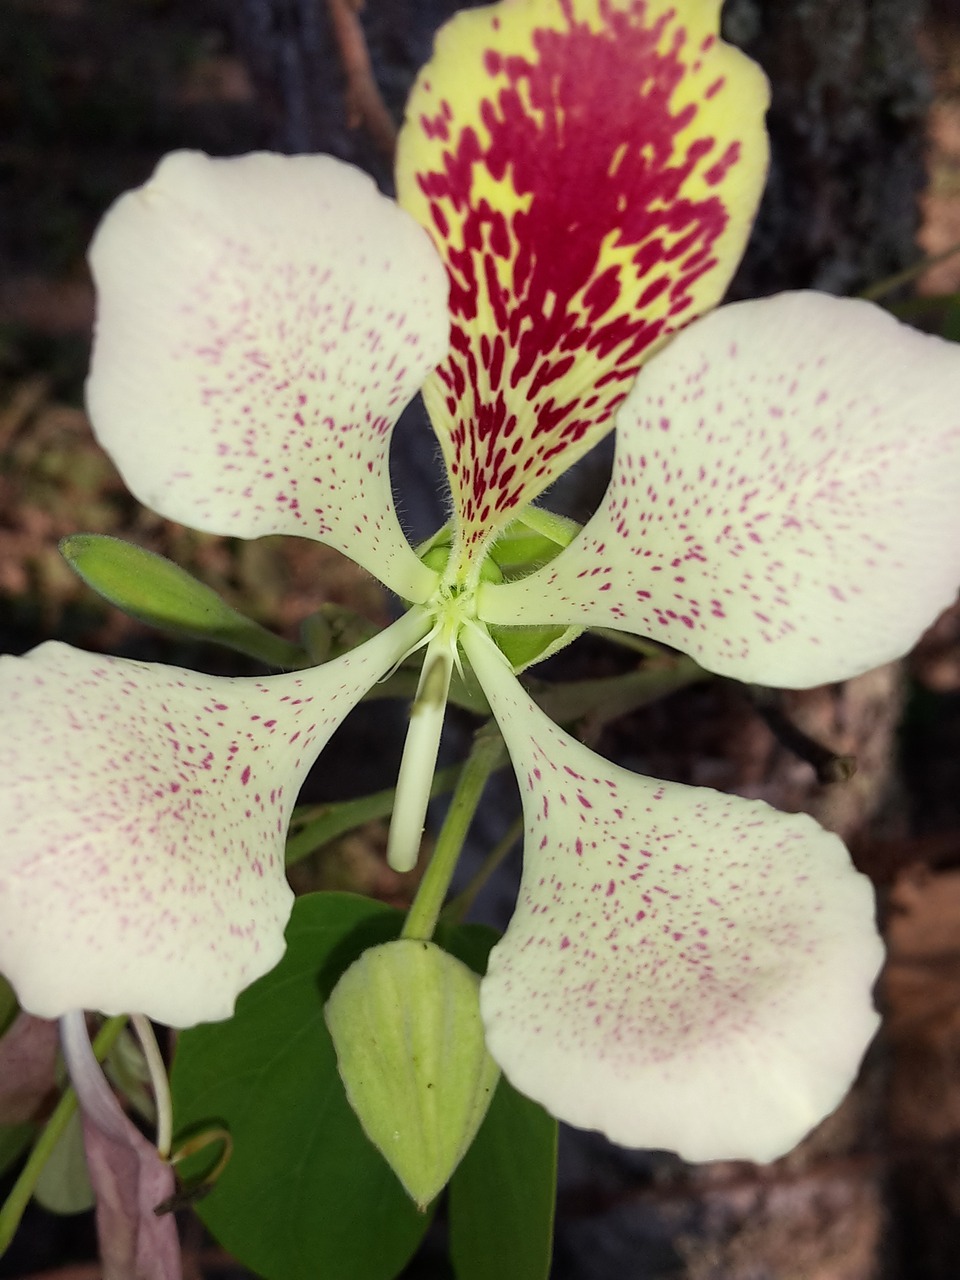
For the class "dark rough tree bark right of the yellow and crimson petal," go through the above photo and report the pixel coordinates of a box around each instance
[723,0,932,297]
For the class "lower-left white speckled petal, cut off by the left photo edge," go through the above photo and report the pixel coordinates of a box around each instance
[0,612,425,1027]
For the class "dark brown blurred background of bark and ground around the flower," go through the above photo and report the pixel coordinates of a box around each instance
[0,0,960,1280]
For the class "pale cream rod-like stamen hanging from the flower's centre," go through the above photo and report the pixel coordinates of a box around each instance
[387,626,456,872]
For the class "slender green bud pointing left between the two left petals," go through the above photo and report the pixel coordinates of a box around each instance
[60,534,310,668]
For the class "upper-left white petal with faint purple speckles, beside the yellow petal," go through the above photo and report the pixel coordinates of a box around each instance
[87,152,449,599]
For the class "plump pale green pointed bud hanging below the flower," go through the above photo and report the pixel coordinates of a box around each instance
[325,938,499,1208]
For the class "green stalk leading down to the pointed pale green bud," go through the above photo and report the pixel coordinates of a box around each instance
[401,724,507,941]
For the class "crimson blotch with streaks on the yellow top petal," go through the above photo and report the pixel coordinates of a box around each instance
[417,0,740,541]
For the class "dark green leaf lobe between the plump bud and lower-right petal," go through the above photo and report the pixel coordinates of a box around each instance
[438,924,558,1280]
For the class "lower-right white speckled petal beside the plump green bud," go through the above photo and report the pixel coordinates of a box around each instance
[463,624,882,1161]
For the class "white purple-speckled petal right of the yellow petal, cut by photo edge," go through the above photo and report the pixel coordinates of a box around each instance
[480,293,960,689]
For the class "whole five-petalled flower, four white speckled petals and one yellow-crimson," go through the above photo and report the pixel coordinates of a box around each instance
[0,0,960,1160]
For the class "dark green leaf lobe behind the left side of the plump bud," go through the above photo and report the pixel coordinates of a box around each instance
[173,893,429,1280]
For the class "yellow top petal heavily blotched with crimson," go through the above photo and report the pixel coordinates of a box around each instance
[397,0,768,570]
